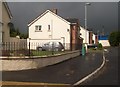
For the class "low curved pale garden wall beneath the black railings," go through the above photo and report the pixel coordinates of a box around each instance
[0,50,80,71]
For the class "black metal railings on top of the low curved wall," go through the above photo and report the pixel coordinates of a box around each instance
[1,42,82,56]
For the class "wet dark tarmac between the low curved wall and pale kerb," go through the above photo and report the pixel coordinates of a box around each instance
[2,52,102,84]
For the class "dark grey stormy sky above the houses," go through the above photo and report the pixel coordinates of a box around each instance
[8,2,118,34]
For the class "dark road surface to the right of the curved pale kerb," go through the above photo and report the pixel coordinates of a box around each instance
[82,47,120,85]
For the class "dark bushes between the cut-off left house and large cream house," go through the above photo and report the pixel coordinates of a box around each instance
[8,22,28,39]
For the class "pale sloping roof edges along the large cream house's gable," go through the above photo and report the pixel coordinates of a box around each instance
[28,10,70,27]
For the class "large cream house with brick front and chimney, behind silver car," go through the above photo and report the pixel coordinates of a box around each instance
[28,9,82,50]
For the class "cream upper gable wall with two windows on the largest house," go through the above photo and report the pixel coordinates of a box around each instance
[29,12,70,39]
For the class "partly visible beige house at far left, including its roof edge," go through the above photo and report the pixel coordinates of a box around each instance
[0,2,12,42]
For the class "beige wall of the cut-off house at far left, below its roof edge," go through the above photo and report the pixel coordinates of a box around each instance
[2,3,10,42]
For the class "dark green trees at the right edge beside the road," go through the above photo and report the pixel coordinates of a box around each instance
[108,31,120,46]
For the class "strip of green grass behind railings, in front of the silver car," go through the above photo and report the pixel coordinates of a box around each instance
[31,51,65,56]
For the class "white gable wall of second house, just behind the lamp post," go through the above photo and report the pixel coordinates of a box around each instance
[80,26,89,43]
